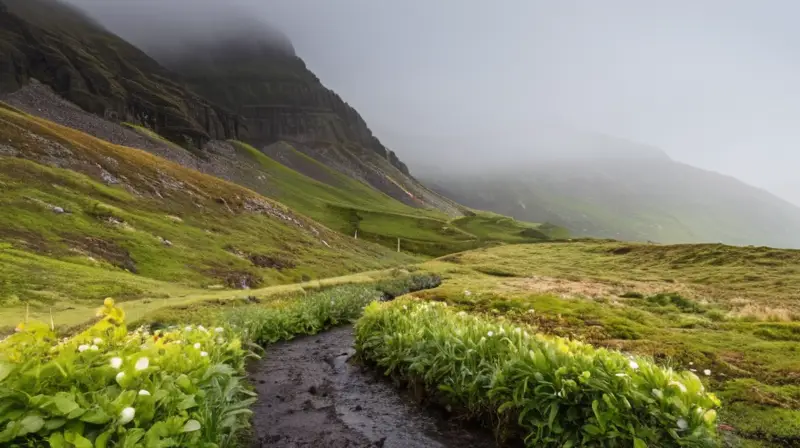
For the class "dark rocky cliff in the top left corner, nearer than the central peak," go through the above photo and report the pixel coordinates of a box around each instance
[0,0,246,147]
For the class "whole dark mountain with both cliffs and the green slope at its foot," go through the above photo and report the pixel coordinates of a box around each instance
[0,0,563,264]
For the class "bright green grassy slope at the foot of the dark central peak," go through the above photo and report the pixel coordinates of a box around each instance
[234,142,564,256]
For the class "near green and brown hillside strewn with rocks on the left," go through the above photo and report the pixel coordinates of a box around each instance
[0,103,414,322]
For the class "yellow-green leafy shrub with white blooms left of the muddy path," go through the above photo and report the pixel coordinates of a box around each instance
[0,299,254,448]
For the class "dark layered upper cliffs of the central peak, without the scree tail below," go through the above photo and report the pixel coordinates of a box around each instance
[163,39,408,175]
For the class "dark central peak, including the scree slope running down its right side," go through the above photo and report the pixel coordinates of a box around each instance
[153,34,460,215]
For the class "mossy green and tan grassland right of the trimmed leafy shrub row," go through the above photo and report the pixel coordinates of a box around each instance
[422,242,800,447]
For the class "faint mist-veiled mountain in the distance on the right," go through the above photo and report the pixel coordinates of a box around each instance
[412,134,800,248]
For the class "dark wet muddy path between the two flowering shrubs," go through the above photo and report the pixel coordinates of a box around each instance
[250,327,495,448]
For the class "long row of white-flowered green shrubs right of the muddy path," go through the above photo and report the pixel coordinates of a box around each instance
[356,299,719,448]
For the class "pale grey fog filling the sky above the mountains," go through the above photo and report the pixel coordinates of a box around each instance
[65,0,800,203]
